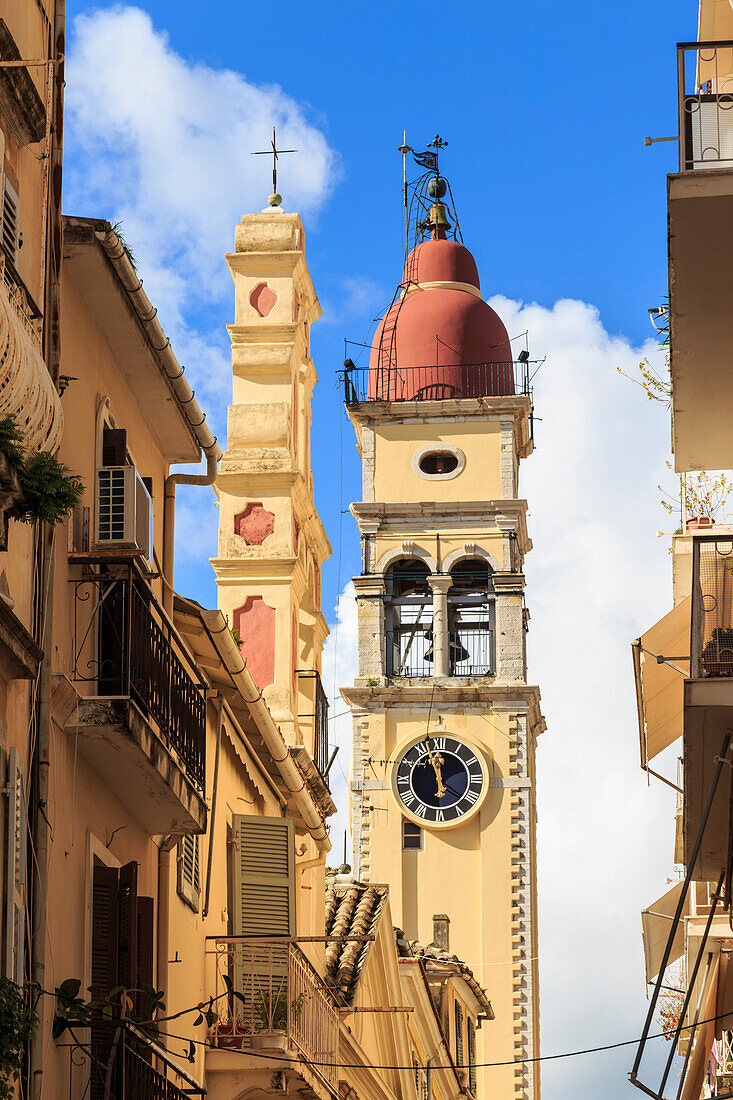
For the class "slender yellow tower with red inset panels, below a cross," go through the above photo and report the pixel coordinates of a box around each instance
[212,206,330,772]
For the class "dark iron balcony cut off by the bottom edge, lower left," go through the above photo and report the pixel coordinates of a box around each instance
[80,1024,206,1100]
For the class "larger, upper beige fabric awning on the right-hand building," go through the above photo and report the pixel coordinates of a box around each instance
[632,596,691,768]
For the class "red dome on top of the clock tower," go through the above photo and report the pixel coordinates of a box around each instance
[369,216,514,400]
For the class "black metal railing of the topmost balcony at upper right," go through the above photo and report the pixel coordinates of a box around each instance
[677,41,733,172]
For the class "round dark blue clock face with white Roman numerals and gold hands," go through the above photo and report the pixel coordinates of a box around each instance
[395,736,485,825]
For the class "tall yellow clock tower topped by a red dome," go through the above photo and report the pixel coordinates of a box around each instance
[342,165,545,1100]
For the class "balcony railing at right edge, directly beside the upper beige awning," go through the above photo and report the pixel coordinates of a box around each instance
[690,535,733,679]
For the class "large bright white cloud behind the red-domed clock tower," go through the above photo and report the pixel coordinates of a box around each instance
[324,298,675,1100]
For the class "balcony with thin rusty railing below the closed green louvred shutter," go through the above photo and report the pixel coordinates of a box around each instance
[206,936,339,1100]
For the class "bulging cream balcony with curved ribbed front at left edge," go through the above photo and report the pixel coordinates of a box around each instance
[0,252,64,451]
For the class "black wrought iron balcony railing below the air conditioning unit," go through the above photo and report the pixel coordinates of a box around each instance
[73,562,206,792]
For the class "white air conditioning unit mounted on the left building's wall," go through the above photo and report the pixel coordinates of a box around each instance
[95,466,153,563]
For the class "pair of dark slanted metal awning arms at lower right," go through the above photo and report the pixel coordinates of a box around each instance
[628,729,733,1100]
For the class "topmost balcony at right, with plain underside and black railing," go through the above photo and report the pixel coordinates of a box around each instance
[667,42,733,472]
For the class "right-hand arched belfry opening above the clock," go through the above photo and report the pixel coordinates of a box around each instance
[448,558,494,677]
